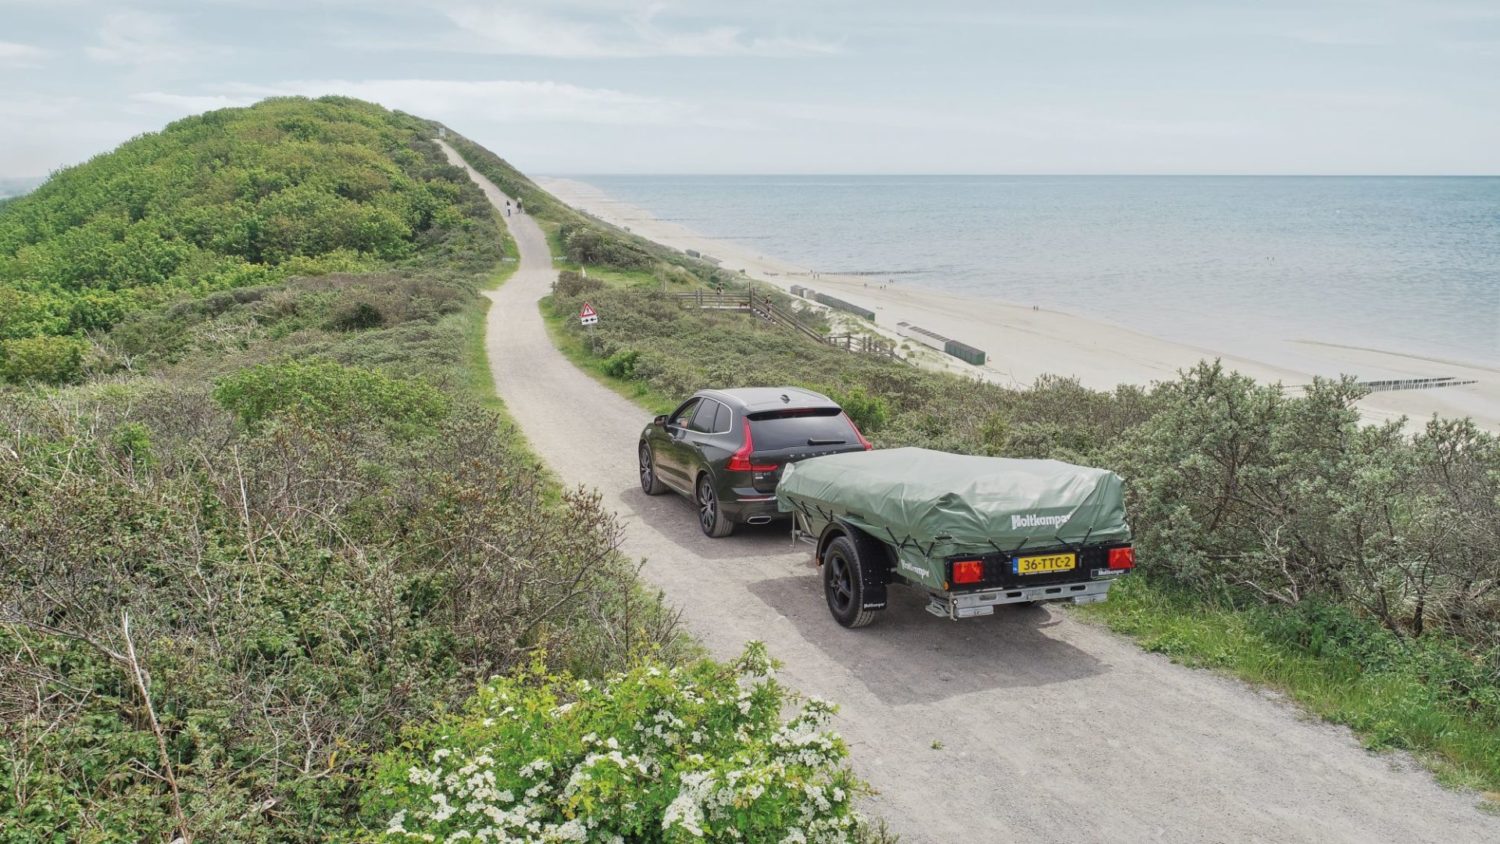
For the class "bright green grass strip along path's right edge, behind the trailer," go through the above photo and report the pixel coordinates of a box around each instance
[1074,577,1500,808]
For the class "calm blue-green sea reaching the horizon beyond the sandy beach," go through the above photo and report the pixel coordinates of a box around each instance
[569,175,1500,375]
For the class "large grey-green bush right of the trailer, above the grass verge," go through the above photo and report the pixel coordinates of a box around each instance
[1112,364,1500,648]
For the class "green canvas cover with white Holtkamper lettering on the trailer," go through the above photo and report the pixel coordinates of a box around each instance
[776,448,1131,559]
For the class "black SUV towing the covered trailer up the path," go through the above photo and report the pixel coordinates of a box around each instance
[639,387,870,537]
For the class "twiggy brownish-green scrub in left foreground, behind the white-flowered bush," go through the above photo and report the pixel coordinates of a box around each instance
[0,373,678,844]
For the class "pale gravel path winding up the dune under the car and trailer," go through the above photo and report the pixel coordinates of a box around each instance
[444,147,1500,844]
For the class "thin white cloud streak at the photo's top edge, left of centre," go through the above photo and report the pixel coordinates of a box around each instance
[446,1,842,58]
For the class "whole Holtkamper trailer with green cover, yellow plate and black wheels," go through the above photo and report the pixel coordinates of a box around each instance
[776,448,1136,628]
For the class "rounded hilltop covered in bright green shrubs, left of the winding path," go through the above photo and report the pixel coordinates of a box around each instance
[0,97,494,381]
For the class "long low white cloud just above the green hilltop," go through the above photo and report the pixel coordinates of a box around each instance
[131,79,710,126]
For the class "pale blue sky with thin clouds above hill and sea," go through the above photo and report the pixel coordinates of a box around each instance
[0,0,1500,177]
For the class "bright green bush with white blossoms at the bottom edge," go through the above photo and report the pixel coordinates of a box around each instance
[368,642,867,844]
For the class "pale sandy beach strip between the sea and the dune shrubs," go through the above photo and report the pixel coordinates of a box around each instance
[537,178,1500,430]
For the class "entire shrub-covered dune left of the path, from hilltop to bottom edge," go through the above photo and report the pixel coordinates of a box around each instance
[0,97,882,843]
